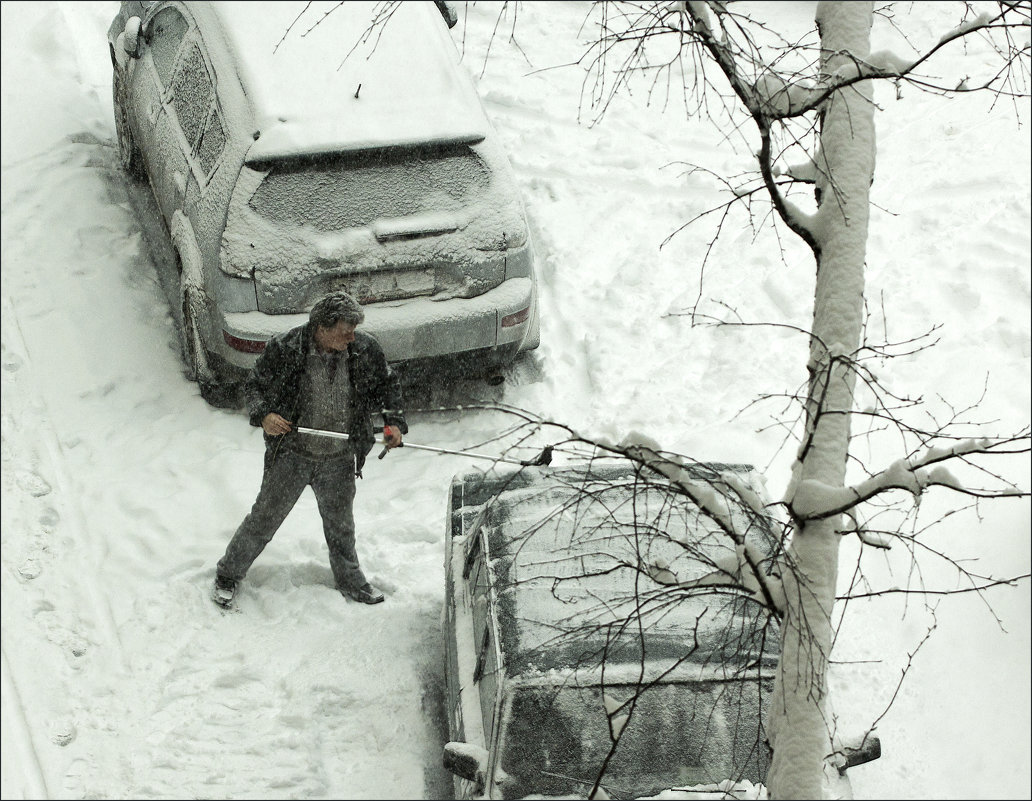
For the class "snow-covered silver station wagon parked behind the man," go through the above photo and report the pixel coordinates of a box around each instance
[107,2,539,403]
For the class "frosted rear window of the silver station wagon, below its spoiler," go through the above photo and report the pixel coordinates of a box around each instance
[250,146,490,231]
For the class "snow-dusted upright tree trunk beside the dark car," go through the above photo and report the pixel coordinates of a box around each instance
[768,2,875,798]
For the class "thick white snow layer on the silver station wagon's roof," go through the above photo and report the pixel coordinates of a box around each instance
[209,2,489,161]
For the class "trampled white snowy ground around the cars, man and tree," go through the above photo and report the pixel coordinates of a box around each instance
[0,2,1032,798]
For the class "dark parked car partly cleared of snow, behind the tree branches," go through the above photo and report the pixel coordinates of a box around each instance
[443,462,880,799]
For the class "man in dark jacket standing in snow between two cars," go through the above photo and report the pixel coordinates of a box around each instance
[213,292,409,607]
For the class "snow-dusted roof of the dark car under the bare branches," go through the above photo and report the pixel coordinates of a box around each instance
[462,462,776,681]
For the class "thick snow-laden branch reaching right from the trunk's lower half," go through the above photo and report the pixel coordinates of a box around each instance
[789,437,1030,520]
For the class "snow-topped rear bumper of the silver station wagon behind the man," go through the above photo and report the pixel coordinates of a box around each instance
[220,278,538,370]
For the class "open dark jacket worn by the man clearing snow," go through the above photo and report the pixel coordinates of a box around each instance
[244,323,409,476]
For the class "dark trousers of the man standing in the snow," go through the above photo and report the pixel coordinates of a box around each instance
[218,448,365,588]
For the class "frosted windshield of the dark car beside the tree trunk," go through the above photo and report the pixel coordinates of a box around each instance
[495,679,773,798]
